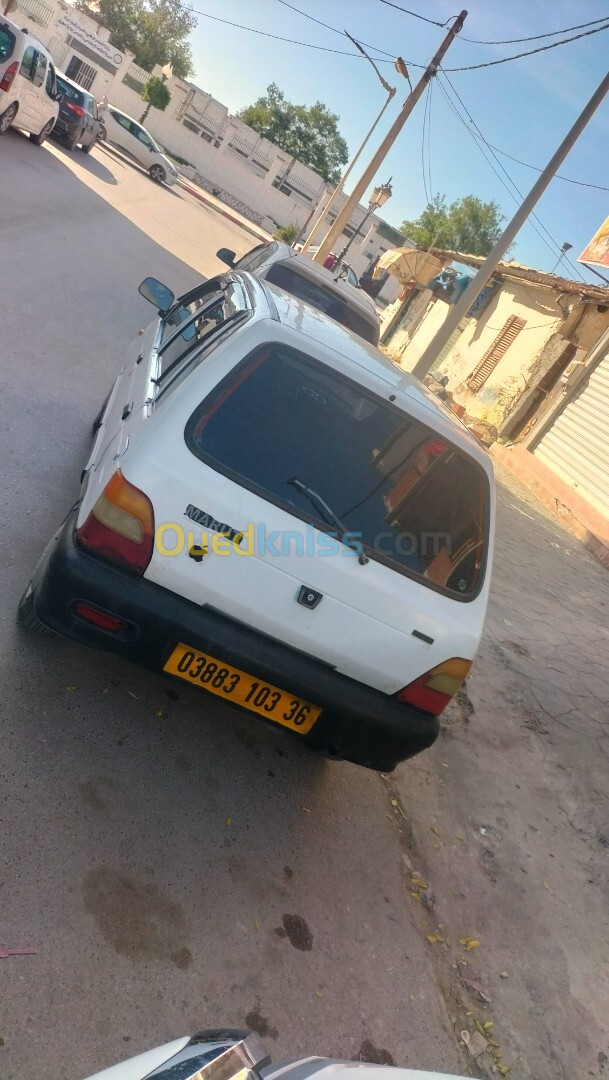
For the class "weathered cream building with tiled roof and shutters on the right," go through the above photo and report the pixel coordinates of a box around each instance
[381,248,609,540]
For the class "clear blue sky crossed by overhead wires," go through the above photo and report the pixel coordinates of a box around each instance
[184,0,609,284]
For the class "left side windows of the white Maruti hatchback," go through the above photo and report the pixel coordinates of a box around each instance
[157,278,249,388]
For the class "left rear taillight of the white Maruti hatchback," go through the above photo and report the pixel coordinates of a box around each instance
[76,469,154,573]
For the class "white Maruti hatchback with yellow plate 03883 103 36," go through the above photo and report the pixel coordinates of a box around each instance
[18,273,495,771]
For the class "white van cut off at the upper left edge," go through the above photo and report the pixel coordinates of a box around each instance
[0,15,60,146]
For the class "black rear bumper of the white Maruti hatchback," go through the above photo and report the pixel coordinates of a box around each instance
[32,509,439,772]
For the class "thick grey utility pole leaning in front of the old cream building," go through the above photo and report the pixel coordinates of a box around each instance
[412,71,609,379]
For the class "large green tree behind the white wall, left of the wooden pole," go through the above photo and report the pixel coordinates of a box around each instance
[236,82,349,184]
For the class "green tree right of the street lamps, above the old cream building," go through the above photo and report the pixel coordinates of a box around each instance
[401,194,504,255]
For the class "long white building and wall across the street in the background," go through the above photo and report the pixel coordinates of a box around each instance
[10,0,401,305]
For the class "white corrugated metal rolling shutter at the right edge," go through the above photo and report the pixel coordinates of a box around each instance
[534,354,609,514]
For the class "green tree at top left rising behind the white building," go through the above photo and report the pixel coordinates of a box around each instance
[77,0,197,79]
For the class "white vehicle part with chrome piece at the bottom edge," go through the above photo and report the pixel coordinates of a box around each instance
[86,1028,475,1080]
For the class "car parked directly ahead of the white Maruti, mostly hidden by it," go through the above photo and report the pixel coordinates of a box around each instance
[216,240,380,345]
